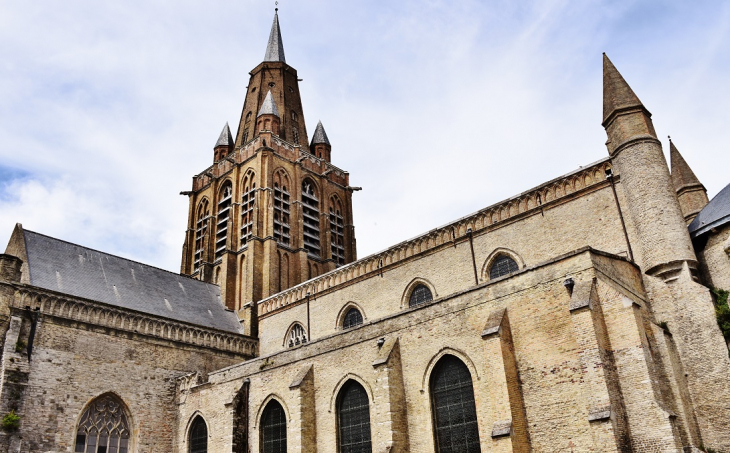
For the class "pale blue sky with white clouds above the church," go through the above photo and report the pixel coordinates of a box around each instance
[0,0,730,271]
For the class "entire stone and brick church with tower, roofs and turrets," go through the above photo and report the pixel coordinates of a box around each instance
[0,9,730,453]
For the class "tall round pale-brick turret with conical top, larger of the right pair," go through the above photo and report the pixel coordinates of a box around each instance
[603,54,697,275]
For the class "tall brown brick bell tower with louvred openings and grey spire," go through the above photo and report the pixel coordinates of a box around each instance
[181,14,356,335]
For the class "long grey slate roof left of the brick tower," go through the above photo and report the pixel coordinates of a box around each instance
[17,230,243,334]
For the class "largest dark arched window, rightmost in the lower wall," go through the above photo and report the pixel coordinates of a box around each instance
[430,355,481,453]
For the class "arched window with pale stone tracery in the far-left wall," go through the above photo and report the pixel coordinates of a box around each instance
[74,395,131,453]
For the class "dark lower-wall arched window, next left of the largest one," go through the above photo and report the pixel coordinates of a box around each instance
[337,380,373,453]
